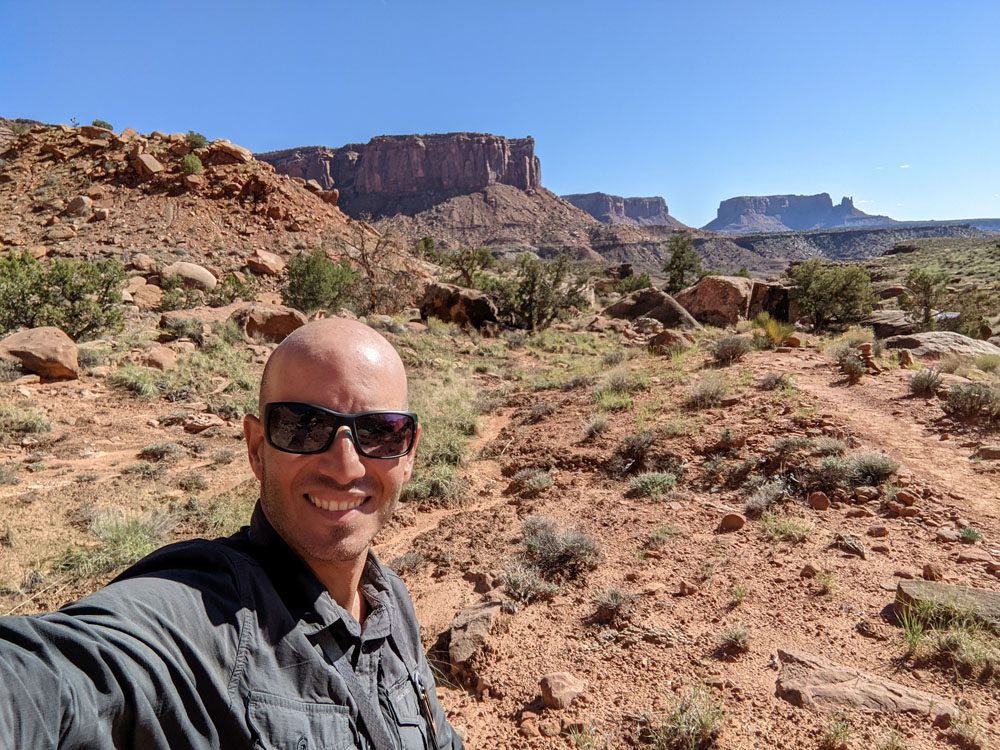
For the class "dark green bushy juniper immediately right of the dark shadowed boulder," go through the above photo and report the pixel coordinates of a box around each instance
[482,253,586,331]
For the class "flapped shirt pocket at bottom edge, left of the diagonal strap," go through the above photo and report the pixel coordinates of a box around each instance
[247,692,357,750]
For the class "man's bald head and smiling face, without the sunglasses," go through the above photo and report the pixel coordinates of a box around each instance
[244,318,420,573]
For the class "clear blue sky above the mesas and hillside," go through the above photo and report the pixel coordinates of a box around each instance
[0,0,1000,226]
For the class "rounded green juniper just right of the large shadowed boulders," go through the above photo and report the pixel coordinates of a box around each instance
[787,258,874,329]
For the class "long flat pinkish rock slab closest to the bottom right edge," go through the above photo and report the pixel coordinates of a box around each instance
[775,648,958,721]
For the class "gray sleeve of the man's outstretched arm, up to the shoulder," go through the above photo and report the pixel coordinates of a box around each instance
[0,558,244,750]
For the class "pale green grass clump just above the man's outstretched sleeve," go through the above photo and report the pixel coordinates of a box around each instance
[53,511,173,580]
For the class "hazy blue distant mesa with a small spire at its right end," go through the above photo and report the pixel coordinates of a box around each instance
[703,193,898,233]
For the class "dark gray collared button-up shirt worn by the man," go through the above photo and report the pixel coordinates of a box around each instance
[0,505,463,750]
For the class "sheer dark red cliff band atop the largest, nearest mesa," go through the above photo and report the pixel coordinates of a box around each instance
[257,133,541,218]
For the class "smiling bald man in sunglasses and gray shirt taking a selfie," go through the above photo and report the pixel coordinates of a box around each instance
[0,318,463,750]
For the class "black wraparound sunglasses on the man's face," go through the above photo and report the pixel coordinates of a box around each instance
[264,401,417,458]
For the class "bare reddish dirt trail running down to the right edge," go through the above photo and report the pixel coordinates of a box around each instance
[772,352,1000,518]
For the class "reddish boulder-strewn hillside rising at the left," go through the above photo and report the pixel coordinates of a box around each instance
[0,125,370,271]
